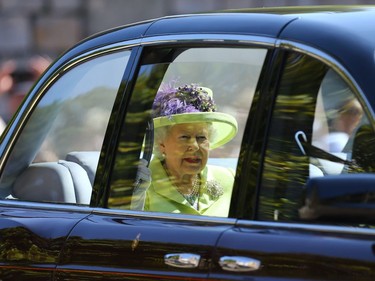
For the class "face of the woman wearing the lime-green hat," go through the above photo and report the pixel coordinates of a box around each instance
[159,123,210,178]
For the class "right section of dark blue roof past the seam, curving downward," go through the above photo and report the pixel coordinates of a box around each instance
[280,9,375,107]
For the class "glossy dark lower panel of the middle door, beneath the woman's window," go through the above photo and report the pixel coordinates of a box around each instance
[58,212,234,280]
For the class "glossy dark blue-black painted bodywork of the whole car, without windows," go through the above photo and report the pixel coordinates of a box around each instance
[0,4,375,280]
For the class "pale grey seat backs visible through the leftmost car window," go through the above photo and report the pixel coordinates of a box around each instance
[12,151,99,205]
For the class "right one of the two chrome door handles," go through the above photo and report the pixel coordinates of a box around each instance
[219,256,261,272]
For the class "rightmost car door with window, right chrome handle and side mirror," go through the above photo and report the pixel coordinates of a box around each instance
[210,45,375,280]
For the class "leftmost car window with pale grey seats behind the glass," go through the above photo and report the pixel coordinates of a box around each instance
[0,51,130,204]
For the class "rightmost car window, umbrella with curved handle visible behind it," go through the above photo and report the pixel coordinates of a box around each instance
[258,50,375,223]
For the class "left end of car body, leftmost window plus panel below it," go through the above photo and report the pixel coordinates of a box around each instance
[0,46,131,280]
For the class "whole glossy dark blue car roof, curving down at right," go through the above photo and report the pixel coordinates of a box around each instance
[52,6,375,104]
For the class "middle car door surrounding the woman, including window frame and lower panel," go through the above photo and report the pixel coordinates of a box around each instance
[57,38,272,280]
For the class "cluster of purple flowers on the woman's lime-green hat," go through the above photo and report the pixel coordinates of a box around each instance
[152,83,216,117]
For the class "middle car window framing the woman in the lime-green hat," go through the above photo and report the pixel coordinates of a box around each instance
[109,47,267,217]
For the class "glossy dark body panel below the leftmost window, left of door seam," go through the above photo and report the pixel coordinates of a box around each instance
[0,204,87,280]
